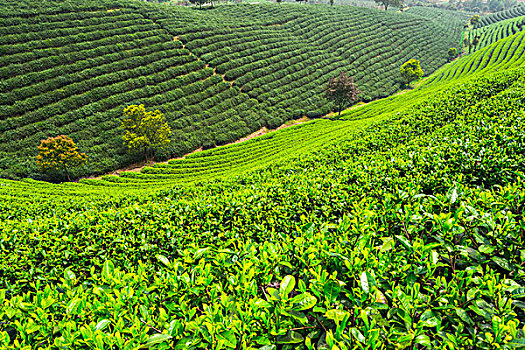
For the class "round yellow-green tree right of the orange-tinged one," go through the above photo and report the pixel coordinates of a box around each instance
[122,105,171,161]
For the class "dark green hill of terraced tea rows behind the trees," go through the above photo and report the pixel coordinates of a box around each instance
[0,0,462,178]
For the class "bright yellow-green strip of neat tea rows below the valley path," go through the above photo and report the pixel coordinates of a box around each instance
[0,24,525,194]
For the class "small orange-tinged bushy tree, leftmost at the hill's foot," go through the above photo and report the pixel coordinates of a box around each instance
[36,135,87,181]
